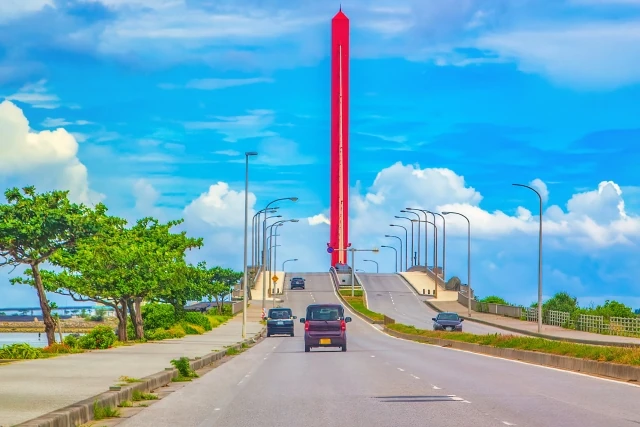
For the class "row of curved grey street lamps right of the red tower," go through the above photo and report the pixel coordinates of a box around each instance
[378,184,542,333]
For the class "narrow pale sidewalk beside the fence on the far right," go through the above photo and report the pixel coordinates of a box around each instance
[428,300,640,345]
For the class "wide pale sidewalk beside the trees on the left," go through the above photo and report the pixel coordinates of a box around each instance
[0,301,263,427]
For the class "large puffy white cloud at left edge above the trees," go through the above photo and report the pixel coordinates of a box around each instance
[0,101,104,204]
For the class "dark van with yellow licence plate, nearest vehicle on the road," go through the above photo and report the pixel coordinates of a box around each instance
[300,304,351,353]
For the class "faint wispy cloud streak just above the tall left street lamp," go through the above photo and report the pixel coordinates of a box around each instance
[185,110,277,142]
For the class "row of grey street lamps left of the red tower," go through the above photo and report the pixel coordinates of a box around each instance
[242,151,298,338]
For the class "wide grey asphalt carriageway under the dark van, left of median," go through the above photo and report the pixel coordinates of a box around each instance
[120,273,640,427]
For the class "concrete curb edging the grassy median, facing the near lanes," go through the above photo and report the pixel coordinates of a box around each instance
[384,327,640,382]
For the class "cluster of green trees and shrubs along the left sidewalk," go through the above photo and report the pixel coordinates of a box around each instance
[0,187,241,348]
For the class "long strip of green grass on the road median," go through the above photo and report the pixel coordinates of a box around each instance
[387,323,640,366]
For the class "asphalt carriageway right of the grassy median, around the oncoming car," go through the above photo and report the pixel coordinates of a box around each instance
[358,273,520,335]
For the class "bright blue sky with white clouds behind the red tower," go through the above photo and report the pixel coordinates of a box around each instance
[0,0,640,308]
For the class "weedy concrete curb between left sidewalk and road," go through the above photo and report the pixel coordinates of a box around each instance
[16,328,266,427]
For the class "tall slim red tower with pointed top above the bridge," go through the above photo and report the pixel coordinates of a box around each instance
[329,8,349,266]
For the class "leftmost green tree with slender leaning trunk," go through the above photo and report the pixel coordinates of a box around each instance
[0,187,106,345]
